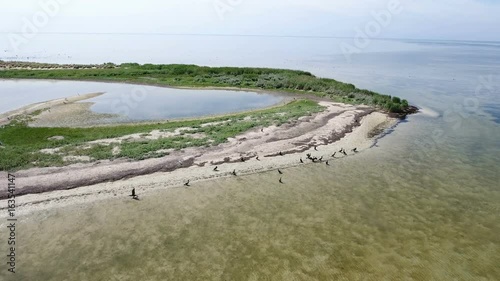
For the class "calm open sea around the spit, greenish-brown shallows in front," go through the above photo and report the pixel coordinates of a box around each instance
[0,35,500,280]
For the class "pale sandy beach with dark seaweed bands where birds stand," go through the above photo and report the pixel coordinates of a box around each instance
[0,93,398,217]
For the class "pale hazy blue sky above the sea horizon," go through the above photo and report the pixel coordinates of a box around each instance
[0,0,500,41]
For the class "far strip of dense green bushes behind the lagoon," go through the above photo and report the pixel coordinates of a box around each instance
[0,61,409,114]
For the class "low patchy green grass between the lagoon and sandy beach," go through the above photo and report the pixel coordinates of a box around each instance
[0,100,324,171]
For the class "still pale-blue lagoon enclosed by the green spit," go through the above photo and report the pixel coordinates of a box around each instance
[0,80,283,122]
